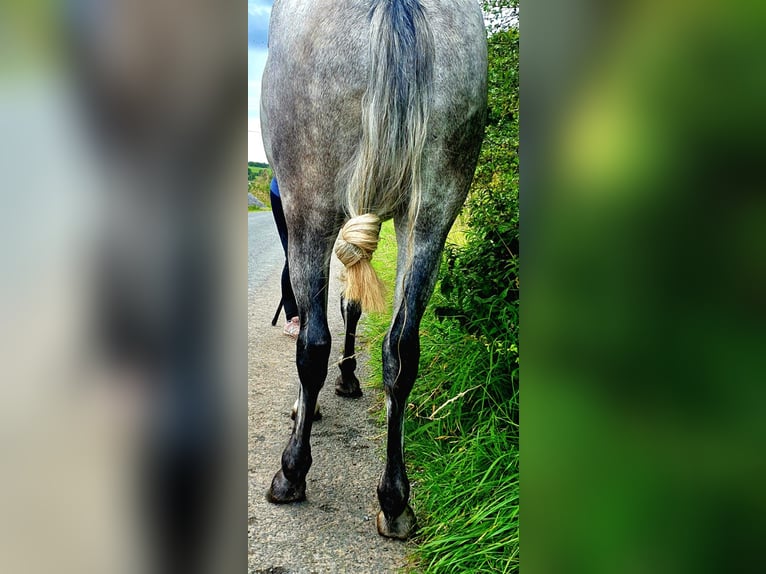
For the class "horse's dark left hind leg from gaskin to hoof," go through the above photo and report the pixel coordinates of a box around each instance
[266,246,331,503]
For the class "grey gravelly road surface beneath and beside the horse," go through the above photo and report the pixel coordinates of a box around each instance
[248,212,406,574]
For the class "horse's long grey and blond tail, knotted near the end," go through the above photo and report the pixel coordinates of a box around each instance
[335,0,434,310]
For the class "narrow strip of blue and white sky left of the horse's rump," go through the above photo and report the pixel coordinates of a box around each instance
[247,0,274,162]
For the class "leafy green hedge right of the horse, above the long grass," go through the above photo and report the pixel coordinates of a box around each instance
[436,25,519,396]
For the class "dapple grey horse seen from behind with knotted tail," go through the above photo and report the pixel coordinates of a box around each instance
[261,0,487,539]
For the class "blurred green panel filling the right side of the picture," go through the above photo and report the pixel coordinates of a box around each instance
[520,1,766,574]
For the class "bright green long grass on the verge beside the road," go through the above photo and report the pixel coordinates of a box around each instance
[363,223,519,573]
